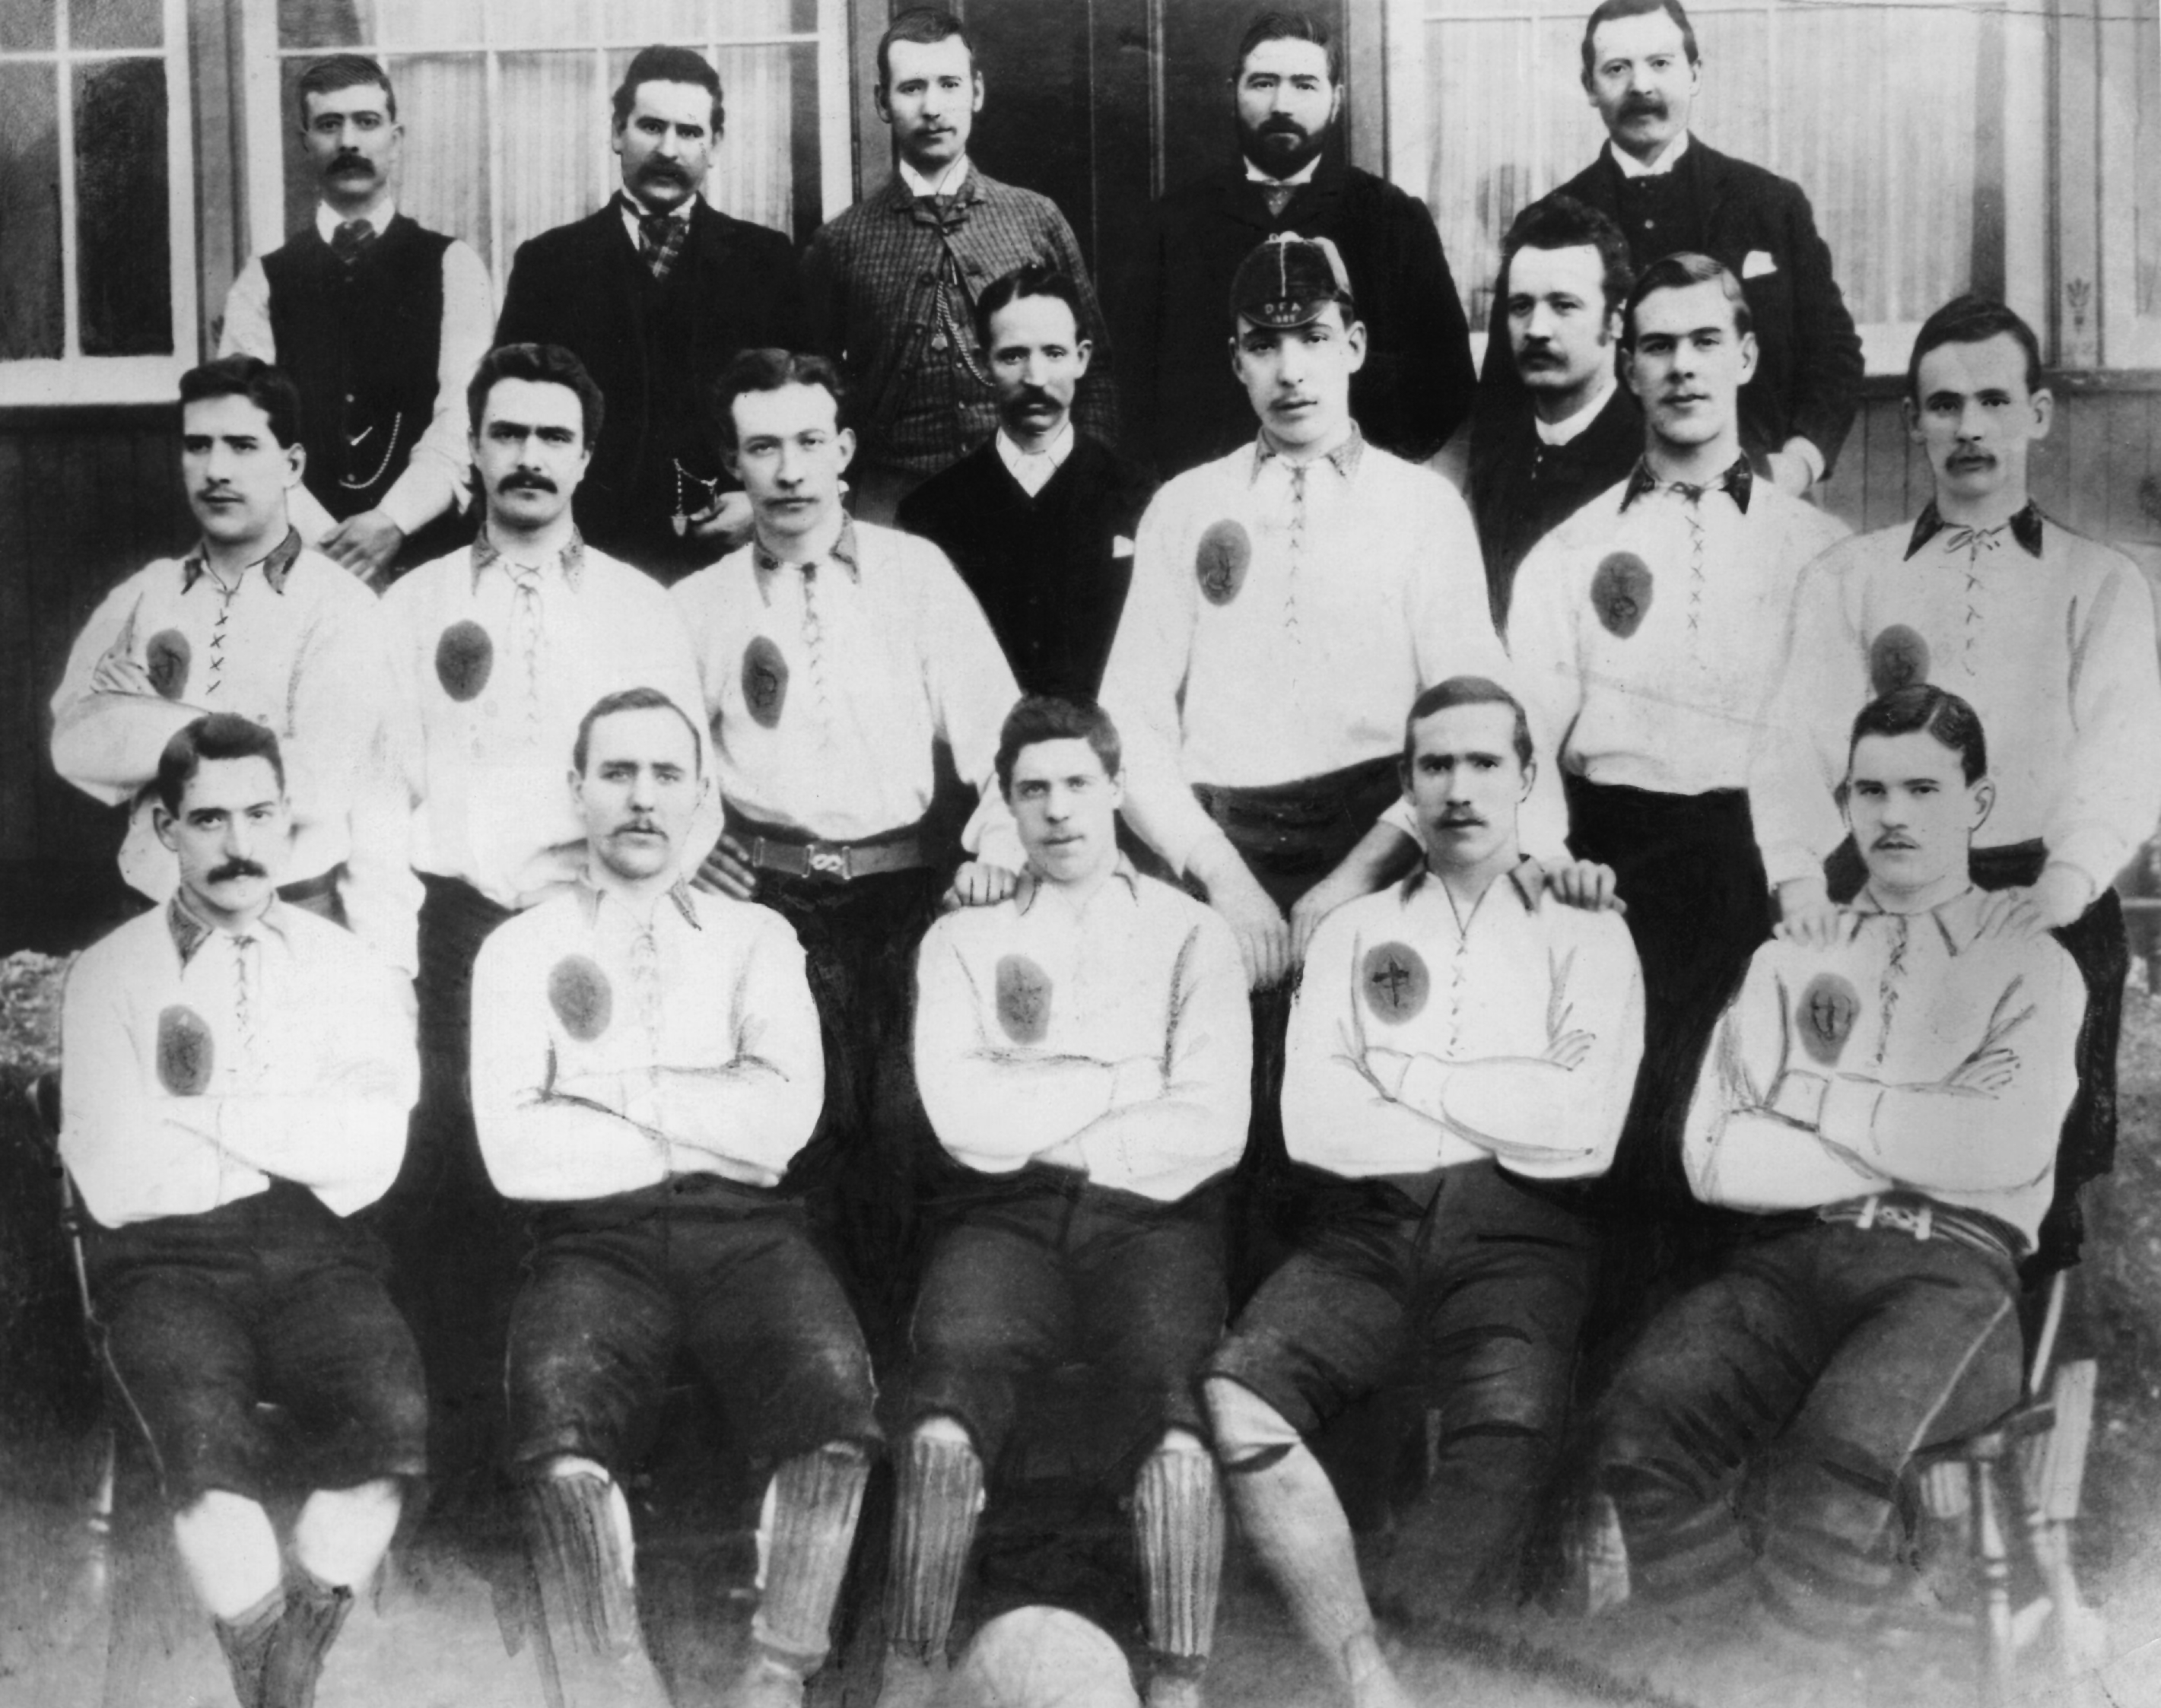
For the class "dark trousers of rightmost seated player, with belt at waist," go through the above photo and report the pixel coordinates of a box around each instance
[1599,1222,2023,1633]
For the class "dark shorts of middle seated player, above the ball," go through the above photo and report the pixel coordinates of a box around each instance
[907,1166,1228,1464]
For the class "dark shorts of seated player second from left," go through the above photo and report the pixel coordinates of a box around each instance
[508,1175,879,1471]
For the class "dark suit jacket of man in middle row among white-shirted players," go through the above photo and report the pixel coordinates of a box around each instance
[899,434,1154,697]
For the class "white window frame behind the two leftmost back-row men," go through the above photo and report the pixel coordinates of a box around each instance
[240,0,856,309]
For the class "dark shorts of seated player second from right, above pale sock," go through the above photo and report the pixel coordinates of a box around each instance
[1208,1162,1597,1433]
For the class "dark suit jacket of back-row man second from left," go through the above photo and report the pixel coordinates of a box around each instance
[495,198,809,579]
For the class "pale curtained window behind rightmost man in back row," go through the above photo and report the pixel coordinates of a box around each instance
[1390,0,2048,370]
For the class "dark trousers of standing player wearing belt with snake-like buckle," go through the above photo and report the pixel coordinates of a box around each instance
[758,868,949,1360]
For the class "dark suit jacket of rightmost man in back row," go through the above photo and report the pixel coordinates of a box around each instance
[1483,136,1863,475]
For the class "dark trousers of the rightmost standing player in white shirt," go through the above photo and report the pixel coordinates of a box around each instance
[1824,838,2131,1281]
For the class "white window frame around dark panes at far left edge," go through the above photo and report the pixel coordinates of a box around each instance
[0,0,201,408]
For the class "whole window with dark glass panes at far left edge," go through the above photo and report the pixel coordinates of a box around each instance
[0,0,195,404]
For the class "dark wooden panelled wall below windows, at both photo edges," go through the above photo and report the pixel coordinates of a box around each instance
[0,376,2161,952]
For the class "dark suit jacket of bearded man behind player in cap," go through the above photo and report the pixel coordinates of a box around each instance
[1117,149,1476,478]
